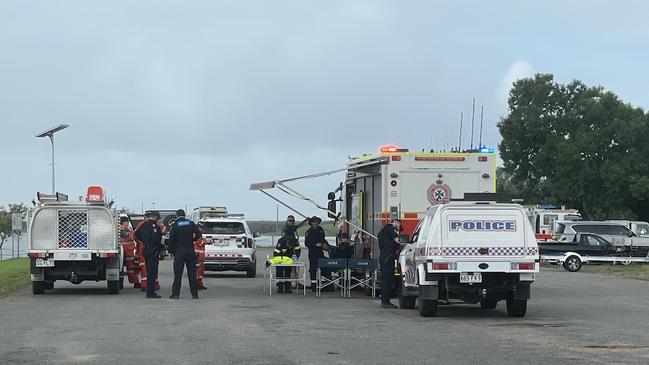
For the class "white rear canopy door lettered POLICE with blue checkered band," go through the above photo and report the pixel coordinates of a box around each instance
[440,203,529,261]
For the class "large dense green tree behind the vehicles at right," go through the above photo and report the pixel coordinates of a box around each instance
[498,74,649,220]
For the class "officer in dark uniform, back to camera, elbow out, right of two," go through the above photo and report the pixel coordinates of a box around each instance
[169,209,203,299]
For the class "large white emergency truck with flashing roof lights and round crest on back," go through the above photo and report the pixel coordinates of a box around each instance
[329,145,496,258]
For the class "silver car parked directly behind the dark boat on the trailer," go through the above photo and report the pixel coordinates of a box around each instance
[553,221,649,246]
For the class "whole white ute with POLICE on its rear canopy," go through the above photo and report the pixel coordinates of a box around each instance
[399,201,539,317]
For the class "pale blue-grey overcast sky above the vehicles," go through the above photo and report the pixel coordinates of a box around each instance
[0,0,649,218]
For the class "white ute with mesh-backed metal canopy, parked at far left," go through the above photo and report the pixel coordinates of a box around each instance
[28,186,124,294]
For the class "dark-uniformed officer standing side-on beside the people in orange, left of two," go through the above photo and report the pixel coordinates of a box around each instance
[135,212,164,298]
